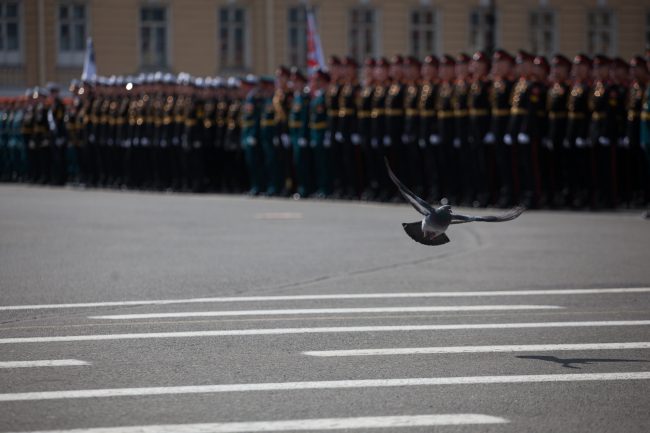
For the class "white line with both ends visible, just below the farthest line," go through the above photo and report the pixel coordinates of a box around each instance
[88,305,564,320]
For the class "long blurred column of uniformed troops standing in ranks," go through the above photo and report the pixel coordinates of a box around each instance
[0,50,650,208]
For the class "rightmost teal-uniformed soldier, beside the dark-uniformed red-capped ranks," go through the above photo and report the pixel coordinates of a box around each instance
[309,70,332,198]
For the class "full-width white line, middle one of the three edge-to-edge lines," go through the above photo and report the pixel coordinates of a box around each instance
[0,320,650,344]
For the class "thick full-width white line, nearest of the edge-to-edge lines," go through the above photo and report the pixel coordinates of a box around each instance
[0,371,650,402]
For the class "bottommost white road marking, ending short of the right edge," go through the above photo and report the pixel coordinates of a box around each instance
[1,413,509,433]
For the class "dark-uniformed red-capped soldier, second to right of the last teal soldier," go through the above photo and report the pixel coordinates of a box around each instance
[335,57,362,199]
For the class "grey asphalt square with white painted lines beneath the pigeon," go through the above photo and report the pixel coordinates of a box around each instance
[0,185,650,433]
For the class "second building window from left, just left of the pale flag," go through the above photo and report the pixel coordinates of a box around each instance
[58,2,87,66]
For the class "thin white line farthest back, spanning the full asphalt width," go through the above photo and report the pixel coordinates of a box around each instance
[0,287,650,311]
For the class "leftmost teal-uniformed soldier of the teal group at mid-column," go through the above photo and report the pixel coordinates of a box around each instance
[241,75,265,195]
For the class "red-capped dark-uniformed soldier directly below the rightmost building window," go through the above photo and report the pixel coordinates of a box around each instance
[589,55,620,207]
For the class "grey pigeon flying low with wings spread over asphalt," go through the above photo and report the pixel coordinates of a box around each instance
[384,158,525,245]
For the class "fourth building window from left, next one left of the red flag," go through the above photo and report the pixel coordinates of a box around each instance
[219,7,248,71]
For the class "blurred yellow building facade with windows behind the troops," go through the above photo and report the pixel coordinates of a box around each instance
[0,0,650,93]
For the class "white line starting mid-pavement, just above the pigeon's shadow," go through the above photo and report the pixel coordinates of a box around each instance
[303,342,650,357]
